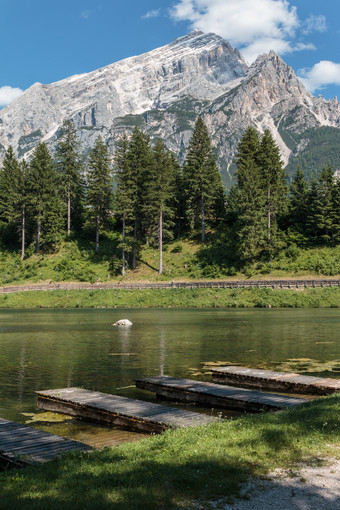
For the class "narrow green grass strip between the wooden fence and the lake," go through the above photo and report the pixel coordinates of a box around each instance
[0,288,340,308]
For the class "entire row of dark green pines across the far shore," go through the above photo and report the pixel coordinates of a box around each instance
[0,117,340,275]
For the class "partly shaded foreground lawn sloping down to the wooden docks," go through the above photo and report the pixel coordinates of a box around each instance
[0,395,340,510]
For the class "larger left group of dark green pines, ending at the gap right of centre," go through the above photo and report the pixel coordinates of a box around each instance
[0,117,224,274]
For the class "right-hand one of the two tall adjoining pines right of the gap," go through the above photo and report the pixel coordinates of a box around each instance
[257,129,287,254]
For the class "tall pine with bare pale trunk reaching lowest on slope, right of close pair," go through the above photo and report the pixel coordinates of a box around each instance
[144,140,175,274]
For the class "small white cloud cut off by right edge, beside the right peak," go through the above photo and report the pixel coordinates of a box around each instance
[299,60,340,92]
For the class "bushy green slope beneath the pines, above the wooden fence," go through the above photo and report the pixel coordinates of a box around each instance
[0,238,340,285]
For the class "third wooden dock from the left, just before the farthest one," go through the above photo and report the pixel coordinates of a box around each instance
[135,377,307,412]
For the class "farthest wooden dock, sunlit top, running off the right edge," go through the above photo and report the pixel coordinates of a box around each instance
[210,366,340,395]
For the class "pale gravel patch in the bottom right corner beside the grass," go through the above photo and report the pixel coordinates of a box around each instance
[218,460,340,510]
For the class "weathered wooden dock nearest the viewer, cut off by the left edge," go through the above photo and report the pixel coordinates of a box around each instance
[0,418,92,467]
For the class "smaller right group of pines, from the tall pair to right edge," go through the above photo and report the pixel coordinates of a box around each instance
[226,127,340,262]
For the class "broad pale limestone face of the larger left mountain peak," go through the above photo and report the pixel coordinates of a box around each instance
[0,31,248,156]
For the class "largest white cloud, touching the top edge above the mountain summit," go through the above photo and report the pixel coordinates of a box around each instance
[170,0,318,62]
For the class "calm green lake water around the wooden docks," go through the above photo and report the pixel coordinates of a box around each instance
[0,309,340,443]
